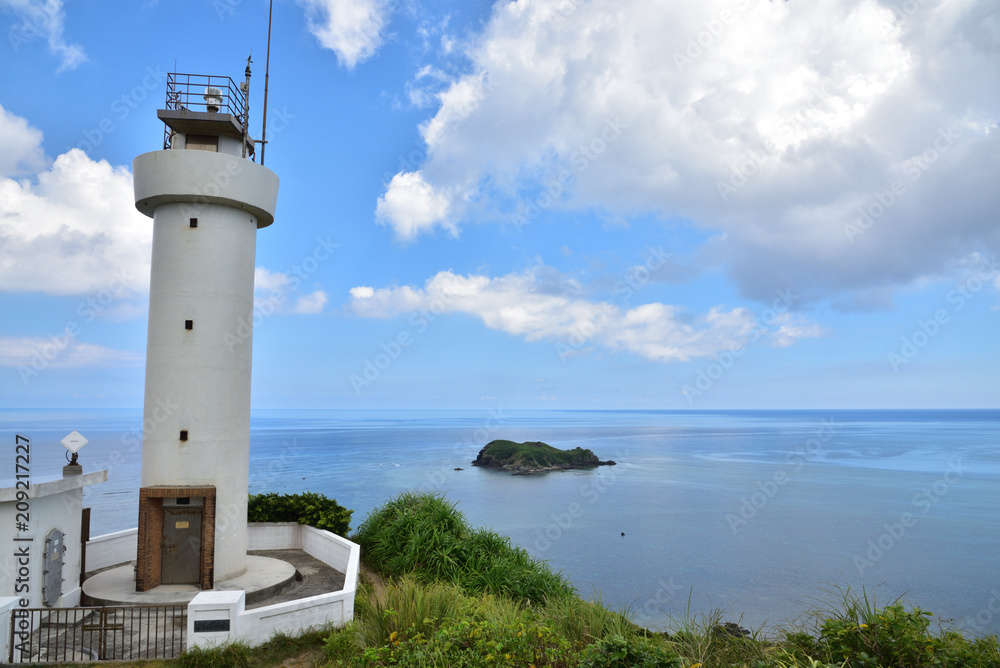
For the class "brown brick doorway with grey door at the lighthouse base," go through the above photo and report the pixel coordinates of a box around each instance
[135,485,215,592]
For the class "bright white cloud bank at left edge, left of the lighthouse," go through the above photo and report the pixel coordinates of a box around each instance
[0,112,153,297]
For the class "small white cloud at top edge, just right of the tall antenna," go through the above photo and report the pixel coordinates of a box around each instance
[299,0,392,69]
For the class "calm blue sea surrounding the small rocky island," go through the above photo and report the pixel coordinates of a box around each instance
[0,410,1000,634]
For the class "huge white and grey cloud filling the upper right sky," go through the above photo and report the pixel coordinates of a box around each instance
[378,0,1000,303]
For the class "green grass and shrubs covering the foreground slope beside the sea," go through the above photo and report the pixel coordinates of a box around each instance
[119,493,1000,668]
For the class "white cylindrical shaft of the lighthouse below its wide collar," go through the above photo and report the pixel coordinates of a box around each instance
[142,197,257,580]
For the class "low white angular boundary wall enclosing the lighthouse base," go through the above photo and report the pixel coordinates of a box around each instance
[87,522,361,648]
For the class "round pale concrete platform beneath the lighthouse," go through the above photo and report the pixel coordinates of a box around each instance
[83,555,296,605]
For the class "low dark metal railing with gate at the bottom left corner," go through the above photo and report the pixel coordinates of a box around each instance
[4,605,187,663]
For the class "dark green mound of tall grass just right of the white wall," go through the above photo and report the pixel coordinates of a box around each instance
[354,492,574,603]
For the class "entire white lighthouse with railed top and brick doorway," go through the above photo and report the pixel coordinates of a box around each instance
[132,64,278,592]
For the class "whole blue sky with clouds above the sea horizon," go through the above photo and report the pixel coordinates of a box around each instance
[0,0,1000,409]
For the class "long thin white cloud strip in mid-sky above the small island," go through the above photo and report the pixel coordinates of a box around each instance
[348,267,820,362]
